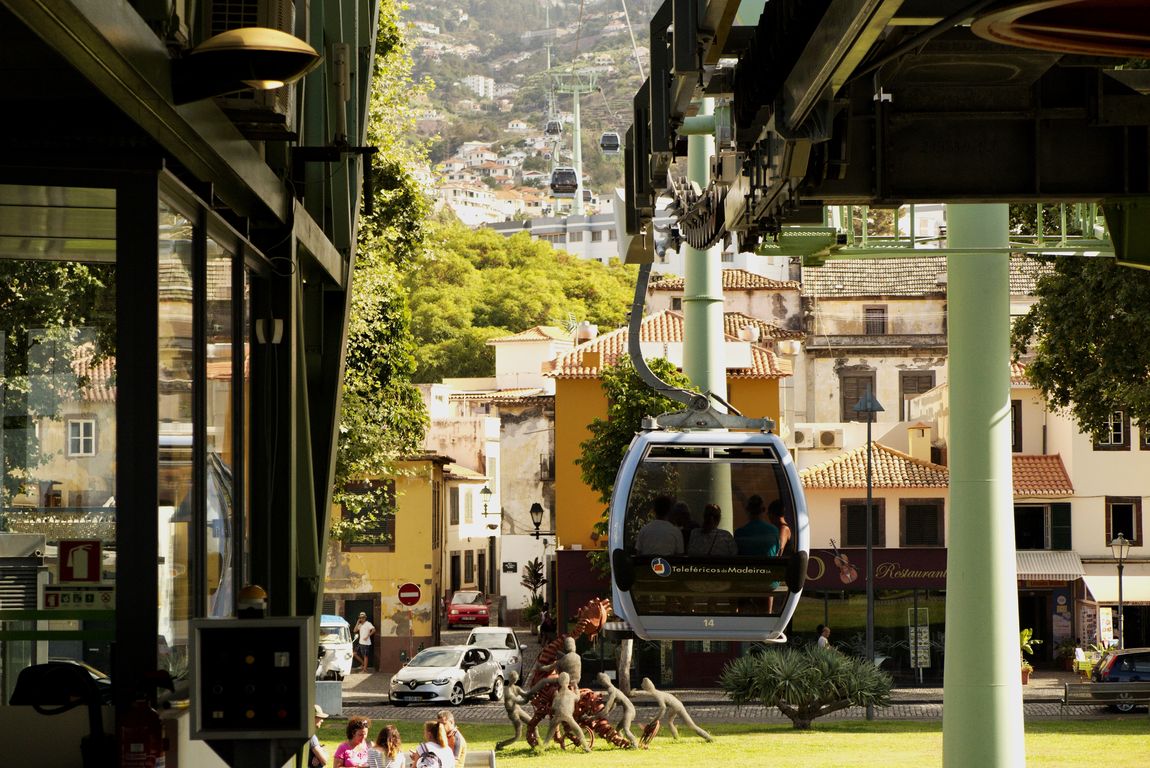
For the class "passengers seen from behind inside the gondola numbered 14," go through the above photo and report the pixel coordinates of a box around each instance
[635,494,791,558]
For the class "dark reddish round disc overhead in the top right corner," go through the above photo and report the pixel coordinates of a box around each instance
[971,0,1150,59]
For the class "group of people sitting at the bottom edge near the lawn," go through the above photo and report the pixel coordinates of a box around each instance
[307,705,467,768]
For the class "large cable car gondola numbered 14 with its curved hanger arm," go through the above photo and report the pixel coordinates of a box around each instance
[607,264,811,642]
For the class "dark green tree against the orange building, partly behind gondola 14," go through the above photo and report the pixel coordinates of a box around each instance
[575,358,692,574]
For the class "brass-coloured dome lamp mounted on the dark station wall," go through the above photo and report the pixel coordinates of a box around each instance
[171,26,323,103]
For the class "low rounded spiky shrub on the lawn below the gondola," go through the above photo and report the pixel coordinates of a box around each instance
[719,645,894,730]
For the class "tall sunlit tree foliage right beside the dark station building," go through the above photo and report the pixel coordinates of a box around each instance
[335,2,430,524]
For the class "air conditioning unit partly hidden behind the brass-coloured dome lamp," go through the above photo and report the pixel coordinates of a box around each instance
[205,0,296,138]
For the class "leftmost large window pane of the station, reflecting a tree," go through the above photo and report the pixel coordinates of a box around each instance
[0,185,116,676]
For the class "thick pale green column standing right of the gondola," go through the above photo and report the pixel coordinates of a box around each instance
[943,205,1026,768]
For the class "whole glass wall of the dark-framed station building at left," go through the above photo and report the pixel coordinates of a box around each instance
[0,183,258,700]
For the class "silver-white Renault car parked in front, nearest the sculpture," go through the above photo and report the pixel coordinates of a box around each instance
[388,645,504,707]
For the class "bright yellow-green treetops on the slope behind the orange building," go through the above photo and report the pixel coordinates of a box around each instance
[405,217,635,382]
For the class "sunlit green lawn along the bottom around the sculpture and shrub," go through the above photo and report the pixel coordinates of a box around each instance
[320,713,1150,768]
